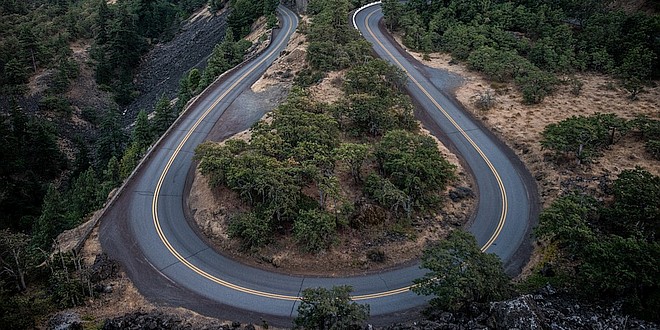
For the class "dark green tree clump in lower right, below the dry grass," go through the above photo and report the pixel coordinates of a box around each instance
[536,168,660,321]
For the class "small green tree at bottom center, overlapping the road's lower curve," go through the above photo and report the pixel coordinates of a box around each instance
[293,286,369,330]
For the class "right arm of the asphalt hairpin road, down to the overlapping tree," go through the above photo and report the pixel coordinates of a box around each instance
[354,5,538,274]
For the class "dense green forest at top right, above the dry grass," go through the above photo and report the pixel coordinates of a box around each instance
[383,0,660,104]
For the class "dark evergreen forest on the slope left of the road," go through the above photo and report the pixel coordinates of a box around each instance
[0,0,277,328]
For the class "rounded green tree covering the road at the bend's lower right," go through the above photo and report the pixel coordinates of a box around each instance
[412,230,510,311]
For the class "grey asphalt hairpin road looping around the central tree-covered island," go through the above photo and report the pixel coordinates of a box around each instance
[99,6,536,326]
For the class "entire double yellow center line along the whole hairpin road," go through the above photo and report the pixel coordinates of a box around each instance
[151,5,507,301]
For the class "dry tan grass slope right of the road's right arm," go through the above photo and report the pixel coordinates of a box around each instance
[400,47,660,205]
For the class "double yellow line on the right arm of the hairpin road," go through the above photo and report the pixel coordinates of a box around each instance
[365,10,508,252]
